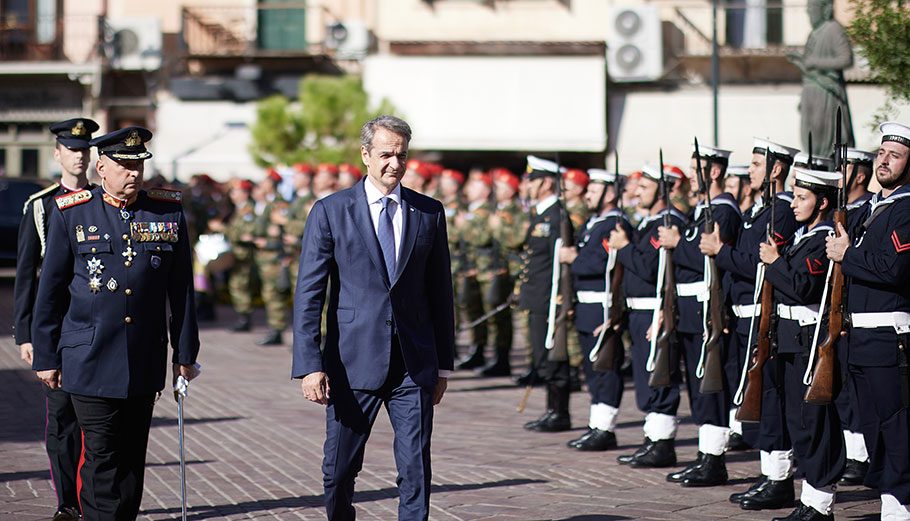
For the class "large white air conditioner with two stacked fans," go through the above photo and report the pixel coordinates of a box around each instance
[607,4,664,82]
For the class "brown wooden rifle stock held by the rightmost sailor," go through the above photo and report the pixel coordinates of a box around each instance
[803,210,847,405]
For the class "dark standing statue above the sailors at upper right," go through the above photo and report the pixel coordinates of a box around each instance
[787,0,854,157]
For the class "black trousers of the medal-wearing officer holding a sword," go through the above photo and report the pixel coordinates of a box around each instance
[71,394,155,521]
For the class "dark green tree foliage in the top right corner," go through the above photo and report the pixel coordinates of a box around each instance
[847,0,910,117]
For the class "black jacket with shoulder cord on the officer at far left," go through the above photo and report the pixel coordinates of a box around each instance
[13,183,92,345]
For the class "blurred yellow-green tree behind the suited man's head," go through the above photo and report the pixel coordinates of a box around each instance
[250,75,393,166]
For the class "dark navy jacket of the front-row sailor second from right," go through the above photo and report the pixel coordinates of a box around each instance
[765,221,834,354]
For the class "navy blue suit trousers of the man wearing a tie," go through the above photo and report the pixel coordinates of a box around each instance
[322,341,435,521]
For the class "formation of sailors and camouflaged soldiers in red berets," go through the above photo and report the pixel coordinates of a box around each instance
[12,116,910,520]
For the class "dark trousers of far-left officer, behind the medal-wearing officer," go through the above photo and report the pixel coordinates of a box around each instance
[44,387,82,508]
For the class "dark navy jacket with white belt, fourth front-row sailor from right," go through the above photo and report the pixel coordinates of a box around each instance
[673,192,742,334]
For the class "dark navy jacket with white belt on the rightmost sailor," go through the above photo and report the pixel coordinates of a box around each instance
[841,186,910,364]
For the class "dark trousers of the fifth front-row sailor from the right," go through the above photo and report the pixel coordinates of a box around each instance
[629,310,681,416]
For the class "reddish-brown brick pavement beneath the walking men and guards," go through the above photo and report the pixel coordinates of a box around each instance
[0,280,878,521]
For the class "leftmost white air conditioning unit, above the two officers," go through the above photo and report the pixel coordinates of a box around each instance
[107,17,161,71]
